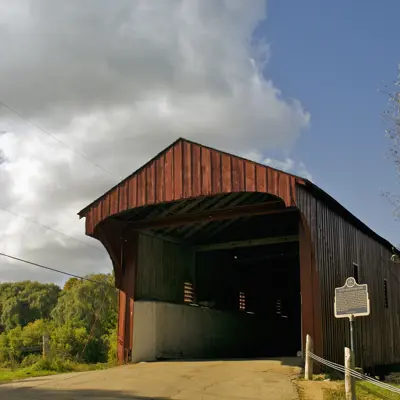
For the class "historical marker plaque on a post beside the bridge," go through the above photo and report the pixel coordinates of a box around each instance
[335,278,370,318]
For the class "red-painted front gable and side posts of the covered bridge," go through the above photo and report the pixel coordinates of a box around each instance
[79,139,322,362]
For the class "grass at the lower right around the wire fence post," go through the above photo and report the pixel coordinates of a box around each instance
[324,382,400,400]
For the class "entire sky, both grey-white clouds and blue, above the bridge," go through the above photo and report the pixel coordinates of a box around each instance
[0,0,400,283]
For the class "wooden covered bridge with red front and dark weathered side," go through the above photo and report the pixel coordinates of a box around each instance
[79,139,400,367]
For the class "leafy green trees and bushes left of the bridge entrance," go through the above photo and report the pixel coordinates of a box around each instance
[0,274,117,365]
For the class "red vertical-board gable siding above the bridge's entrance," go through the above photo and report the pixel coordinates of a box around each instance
[81,140,296,235]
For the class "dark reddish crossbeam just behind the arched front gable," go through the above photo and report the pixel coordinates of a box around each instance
[129,202,297,230]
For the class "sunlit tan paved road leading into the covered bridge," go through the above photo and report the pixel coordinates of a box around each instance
[0,359,299,400]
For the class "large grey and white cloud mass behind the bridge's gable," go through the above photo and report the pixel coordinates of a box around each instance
[0,0,310,281]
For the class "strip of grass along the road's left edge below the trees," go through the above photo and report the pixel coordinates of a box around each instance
[0,360,110,383]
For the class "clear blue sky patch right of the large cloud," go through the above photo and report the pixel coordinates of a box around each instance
[257,0,400,245]
